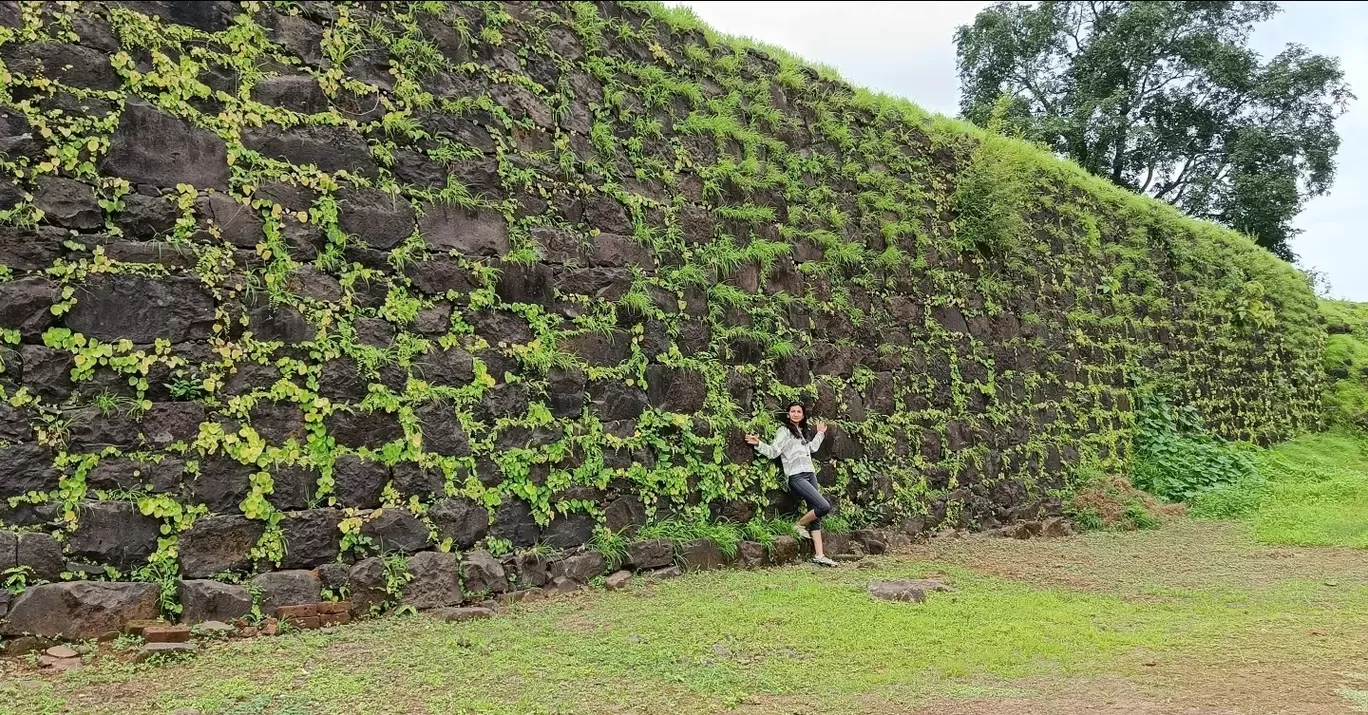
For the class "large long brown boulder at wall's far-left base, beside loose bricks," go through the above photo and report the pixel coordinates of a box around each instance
[0,581,161,640]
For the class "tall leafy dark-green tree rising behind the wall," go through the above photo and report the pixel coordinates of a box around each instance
[955,0,1354,260]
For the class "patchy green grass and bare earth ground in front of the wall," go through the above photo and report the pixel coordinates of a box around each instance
[0,432,1368,715]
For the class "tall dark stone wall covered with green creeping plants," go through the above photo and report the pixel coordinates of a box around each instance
[0,1,1321,626]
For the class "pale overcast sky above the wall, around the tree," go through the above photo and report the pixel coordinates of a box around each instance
[670,0,1368,301]
